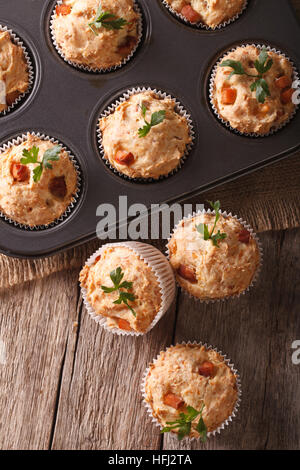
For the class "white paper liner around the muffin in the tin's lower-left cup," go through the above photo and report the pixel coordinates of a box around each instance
[0,131,81,231]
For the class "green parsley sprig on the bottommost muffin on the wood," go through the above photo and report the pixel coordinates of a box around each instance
[161,404,207,442]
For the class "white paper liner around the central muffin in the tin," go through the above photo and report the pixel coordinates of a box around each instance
[97,87,195,183]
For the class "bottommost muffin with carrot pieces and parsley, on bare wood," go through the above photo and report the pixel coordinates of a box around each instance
[144,344,239,440]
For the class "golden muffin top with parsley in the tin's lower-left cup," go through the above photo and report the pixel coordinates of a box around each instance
[0,134,77,227]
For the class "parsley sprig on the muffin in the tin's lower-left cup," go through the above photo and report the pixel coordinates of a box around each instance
[20,145,61,183]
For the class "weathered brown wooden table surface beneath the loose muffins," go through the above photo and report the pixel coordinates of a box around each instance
[0,0,300,450]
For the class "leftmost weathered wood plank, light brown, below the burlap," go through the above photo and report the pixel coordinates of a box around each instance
[0,272,78,449]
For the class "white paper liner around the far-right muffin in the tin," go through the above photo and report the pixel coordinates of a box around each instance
[209,43,299,138]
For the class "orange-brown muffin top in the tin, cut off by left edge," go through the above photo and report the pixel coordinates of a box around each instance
[0,31,29,112]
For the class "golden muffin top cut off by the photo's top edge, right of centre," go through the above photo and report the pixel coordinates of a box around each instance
[166,0,245,28]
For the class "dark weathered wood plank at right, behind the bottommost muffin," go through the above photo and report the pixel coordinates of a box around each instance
[164,229,300,449]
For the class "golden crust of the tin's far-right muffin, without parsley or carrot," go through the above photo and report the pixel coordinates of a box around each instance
[213,45,295,134]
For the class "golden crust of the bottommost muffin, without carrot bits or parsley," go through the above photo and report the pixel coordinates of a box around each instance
[145,344,238,437]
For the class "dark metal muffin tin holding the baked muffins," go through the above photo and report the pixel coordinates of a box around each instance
[0,0,300,258]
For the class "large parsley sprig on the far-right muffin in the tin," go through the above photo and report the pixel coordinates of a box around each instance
[220,47,273,103]
